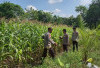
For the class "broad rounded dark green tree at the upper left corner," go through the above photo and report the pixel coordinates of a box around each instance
[0,2,24,18]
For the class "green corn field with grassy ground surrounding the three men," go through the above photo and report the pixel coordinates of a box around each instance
[0,21,100,68]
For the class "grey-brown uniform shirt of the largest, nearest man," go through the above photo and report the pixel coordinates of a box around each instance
[44,32,55,48]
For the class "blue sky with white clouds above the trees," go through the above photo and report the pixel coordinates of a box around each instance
[0,0,92,17]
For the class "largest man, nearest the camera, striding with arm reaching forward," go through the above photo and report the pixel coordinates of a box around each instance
[42,27,57,59]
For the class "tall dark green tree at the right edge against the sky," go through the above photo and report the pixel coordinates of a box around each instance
[86,0,100,28]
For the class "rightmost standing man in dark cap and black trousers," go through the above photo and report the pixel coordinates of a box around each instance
[72,27,79,52]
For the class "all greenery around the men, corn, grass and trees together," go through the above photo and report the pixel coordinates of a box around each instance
[0,0,100,68]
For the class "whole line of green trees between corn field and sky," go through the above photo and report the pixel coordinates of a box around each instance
[0,0,100,29]
